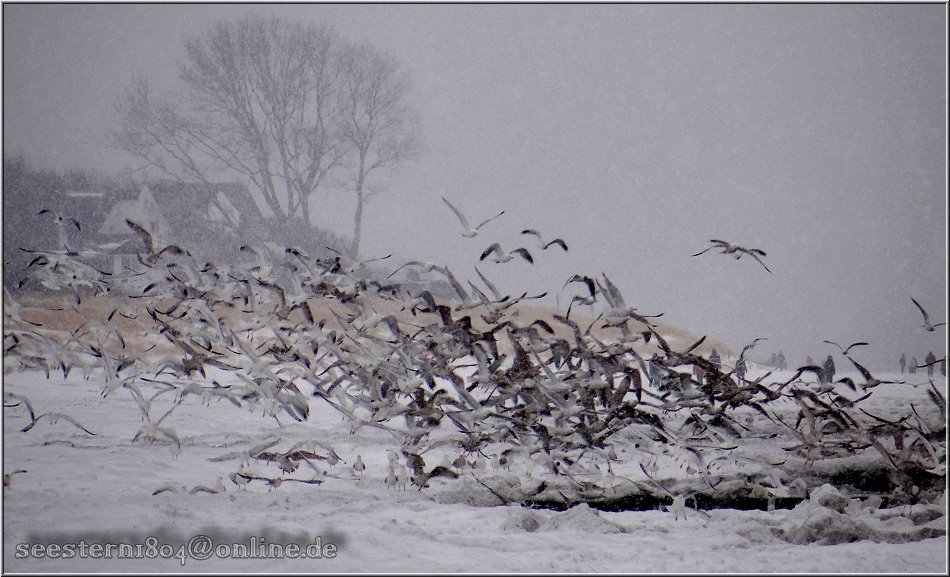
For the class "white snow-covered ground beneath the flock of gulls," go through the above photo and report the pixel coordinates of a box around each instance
[3,358,947,573]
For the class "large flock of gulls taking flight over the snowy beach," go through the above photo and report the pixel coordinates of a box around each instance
[4,198,946,508]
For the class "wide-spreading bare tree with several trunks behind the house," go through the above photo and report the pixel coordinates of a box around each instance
[114,17,347,223]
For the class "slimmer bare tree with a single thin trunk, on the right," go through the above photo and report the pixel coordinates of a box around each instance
[339,45,419,256]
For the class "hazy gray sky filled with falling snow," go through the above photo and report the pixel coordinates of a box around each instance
[3,4,947,369]
